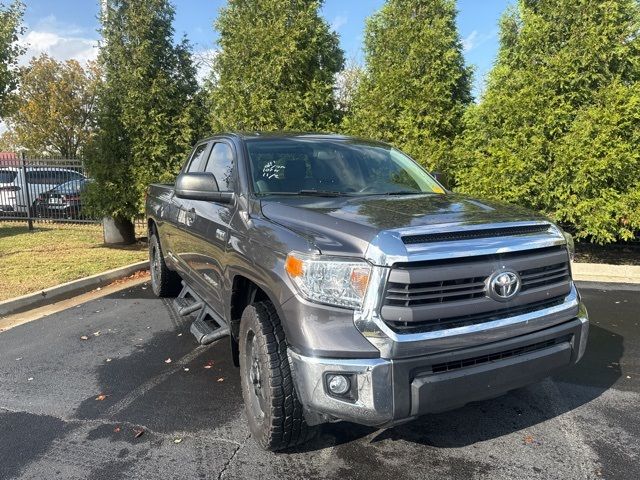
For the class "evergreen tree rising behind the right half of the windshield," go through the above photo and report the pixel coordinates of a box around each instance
[344,0,472,176]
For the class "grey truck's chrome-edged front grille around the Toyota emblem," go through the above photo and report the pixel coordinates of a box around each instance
[381,246,571,333]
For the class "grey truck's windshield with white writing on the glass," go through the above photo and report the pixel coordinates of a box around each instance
[247,138,445,195]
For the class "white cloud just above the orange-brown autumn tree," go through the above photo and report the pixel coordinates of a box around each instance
[20,16,98,64]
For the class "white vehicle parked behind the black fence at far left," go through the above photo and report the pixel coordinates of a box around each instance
[0,167,86,215]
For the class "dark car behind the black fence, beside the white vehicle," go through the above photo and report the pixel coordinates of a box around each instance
[33,178,90,220]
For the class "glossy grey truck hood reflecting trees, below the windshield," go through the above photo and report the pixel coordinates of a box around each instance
[262,194,545,255]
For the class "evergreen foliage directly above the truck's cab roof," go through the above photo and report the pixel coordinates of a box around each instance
[211,0,344,131]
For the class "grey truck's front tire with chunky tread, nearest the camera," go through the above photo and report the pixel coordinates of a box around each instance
[239,302,317,451]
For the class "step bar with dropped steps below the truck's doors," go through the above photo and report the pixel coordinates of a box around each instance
[173,282,229,345]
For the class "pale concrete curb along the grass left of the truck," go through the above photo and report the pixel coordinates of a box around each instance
[0,260,149,317]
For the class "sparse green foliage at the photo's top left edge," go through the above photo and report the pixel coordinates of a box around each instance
[0,0,24,118]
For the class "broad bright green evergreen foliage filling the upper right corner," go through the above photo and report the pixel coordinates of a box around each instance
[456,0,640,243]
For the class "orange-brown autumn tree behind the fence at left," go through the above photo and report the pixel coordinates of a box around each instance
[2,55,99,158]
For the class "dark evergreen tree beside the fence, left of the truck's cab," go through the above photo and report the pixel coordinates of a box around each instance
[88,0,202,240]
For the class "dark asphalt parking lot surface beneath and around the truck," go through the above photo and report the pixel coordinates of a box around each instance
[0,285,640,480]
